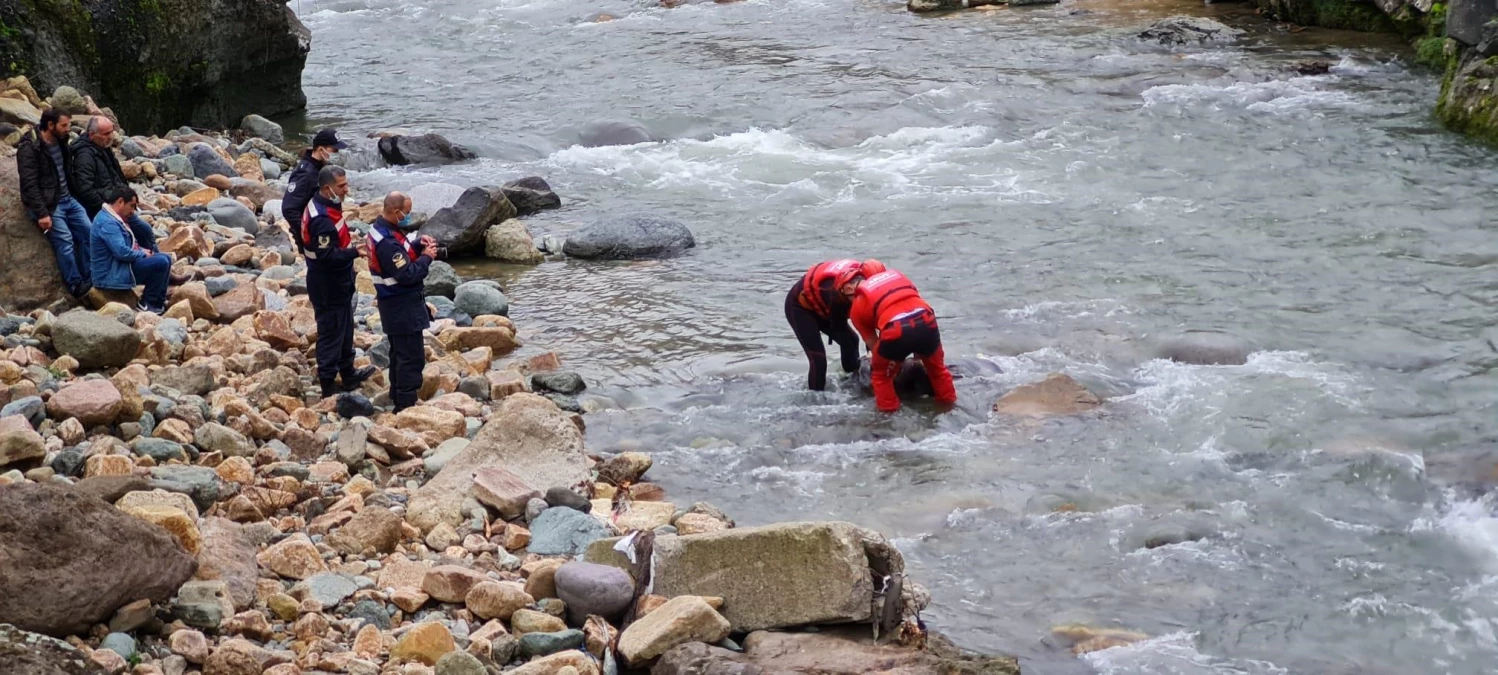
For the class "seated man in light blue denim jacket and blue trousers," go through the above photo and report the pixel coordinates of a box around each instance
[90,187,172,314]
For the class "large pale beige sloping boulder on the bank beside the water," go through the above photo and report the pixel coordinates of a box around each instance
[406,394,589,531]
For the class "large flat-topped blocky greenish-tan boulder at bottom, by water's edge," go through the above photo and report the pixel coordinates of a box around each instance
[590,523,905,633]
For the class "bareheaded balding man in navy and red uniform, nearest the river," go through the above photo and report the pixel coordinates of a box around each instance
[370,216,431,412]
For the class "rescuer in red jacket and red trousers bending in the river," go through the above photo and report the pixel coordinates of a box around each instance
[837,265,957,413]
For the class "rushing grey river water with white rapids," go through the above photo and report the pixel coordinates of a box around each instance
[294,0,1498,675]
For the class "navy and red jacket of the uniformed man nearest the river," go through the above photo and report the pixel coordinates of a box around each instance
[370,217,431,335]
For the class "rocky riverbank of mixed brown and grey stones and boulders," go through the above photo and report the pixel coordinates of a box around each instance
[0,79,1019,675]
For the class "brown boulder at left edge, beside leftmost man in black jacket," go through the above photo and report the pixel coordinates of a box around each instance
[0,155,67,313]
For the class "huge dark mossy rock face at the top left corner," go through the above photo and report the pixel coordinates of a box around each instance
[0,0,312,131]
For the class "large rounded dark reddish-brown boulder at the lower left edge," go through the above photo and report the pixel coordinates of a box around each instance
[0,483,198,636]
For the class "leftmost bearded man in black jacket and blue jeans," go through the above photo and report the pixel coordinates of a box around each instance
[15,109,93,298]
